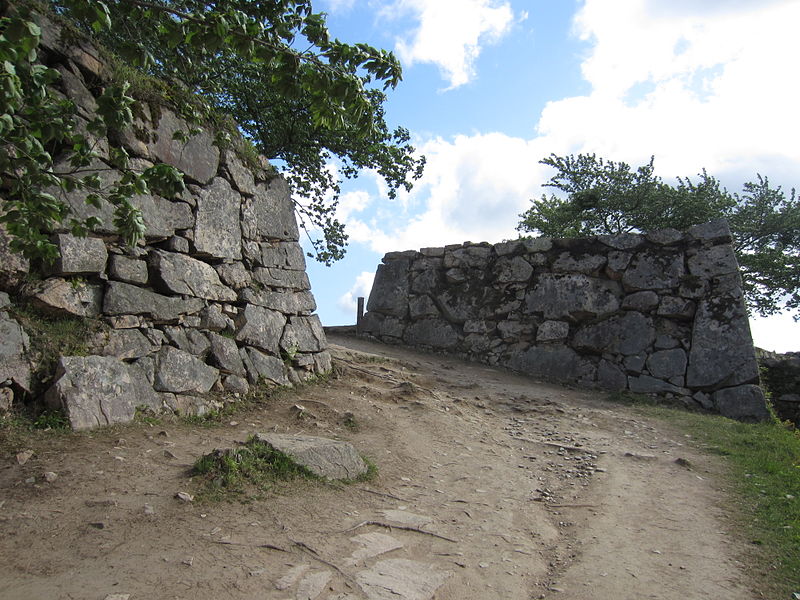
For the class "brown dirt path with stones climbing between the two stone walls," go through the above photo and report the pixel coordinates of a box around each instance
[0,335,755,600]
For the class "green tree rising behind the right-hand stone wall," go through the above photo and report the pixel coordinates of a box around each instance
[517,154,800,319]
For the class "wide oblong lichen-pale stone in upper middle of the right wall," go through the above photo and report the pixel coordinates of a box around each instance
[525,273,622,319]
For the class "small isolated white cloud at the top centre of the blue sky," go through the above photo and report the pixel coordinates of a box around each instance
[388,0,527,89]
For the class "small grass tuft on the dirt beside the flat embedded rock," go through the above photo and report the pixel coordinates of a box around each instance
[192,437,320,501]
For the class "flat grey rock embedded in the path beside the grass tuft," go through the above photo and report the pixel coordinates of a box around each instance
[256,433,368,479]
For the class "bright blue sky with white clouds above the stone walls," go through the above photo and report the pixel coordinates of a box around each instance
[308,0,800,352]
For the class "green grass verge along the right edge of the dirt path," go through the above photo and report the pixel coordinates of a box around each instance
[608,397,800,598]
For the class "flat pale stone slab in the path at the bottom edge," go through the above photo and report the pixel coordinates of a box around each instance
[356,558,453,600]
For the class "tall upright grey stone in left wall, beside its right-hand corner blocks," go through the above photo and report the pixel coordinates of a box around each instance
[194,177,245,259]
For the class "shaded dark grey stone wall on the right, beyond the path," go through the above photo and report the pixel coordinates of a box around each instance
[362,221,768,420]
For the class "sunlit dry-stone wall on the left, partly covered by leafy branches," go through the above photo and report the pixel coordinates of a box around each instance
[0,11,331,429]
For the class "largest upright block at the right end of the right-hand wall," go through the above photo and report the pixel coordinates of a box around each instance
[686,297,758,390]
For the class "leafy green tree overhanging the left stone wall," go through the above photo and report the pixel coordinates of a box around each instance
[0,0,424,263]
